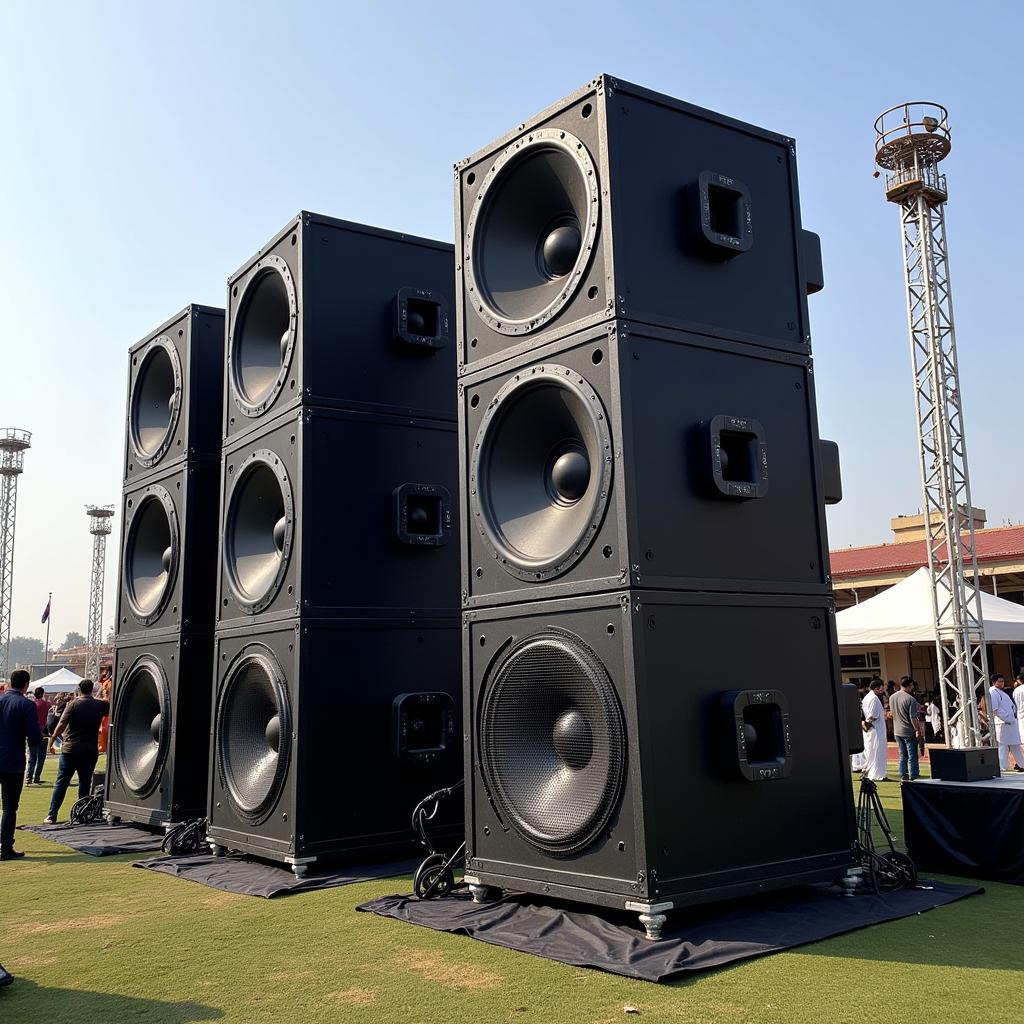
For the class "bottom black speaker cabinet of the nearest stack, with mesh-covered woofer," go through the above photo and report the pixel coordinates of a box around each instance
[463,590,854,929]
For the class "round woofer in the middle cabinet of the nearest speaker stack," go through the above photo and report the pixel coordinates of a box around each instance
[470,364,612,581]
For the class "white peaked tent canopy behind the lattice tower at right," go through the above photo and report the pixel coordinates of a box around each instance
[836,566,1024,646]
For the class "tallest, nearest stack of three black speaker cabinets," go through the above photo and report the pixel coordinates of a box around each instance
[456,77,854,935]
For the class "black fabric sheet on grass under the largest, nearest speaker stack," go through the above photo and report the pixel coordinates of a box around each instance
[357,881,984,981]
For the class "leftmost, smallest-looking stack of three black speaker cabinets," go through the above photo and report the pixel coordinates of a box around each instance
[104,305,224,827]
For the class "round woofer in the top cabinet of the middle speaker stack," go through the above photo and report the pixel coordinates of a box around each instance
[227,255,298,417]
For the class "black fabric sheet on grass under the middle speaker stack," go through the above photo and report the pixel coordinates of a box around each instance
[132,853,419,899]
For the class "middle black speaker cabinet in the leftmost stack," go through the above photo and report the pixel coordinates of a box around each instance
[118,460,220,641]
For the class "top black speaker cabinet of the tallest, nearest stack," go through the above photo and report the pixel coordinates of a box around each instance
[455,75,821,366]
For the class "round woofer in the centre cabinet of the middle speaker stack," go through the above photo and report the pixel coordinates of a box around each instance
[224,449,294,614]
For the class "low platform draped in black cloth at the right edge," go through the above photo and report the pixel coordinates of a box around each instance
[902,776,1024,885]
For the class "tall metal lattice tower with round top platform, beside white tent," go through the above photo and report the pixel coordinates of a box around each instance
[874,101,994,746]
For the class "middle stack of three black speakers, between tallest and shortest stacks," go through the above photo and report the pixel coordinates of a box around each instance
[208,213,462,873]
